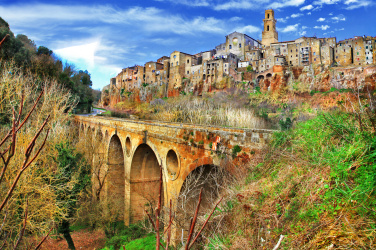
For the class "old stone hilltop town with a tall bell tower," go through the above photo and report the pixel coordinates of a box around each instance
[102,9,376,106]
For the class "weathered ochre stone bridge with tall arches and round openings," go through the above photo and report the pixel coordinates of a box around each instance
[75,116,274,224]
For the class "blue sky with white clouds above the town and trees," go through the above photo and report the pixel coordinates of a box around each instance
[0,0,376,89]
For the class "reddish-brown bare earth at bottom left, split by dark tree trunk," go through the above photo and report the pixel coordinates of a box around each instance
[41,229,106,250]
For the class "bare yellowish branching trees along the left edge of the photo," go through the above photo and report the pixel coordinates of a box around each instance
[0,63,76,249]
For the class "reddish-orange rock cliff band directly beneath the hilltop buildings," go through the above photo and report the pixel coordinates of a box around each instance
[101,65,376,107]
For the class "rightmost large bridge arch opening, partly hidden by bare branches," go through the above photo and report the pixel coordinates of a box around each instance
[175,165,225,235]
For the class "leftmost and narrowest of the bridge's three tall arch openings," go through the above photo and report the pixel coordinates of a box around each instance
[106,135,125,221]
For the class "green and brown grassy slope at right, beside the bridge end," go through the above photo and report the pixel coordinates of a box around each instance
[213,112,376,249]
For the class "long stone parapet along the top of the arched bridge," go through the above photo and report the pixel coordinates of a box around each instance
[75,116,275,152]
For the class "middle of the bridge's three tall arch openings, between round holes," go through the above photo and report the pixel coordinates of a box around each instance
[130,144,163,223]
